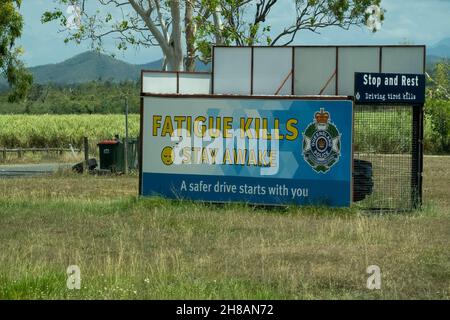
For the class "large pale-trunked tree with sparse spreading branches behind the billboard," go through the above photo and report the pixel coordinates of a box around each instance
[42,0,384,70]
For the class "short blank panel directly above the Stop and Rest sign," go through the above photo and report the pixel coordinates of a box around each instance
[381,46,425,74]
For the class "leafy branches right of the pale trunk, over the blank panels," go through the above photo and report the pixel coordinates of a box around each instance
[195,0,385,61]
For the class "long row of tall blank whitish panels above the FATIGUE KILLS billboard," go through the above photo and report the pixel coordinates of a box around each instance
[211,45,425,96]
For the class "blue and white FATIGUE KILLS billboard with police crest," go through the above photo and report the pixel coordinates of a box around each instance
[140,94,353,206]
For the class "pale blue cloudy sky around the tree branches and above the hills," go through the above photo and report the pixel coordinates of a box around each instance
[15,0,450,67]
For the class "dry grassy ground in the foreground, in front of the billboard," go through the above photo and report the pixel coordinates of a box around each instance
[0,157,450,299]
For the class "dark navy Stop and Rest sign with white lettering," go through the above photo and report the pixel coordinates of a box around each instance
[355,72,425,104]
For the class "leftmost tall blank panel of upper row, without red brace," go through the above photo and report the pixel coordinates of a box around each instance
[213,47,252,94]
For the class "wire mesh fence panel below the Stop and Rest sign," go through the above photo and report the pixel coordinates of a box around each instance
[354,105,423,210]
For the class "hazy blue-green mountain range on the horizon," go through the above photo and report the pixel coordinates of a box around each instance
[0,38,450,89]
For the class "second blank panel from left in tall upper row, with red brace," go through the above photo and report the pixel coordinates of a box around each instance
[253,47,292,95]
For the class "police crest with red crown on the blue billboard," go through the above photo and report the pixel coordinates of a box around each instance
[303,108,341,173]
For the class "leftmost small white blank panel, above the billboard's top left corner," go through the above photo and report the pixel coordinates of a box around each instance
[142,71,177,93]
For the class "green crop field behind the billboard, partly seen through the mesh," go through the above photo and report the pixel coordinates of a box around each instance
[0,113,448,153]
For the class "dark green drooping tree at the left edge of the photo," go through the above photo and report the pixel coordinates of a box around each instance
[0,0,33,101]
